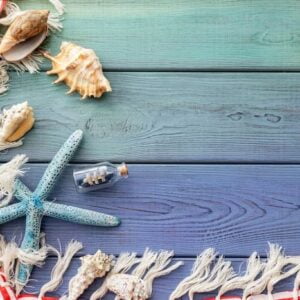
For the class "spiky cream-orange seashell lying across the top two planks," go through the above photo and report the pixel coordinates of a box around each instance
[44,42,112,99]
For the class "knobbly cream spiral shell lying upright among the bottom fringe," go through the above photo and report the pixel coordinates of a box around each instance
[67,250,113,300]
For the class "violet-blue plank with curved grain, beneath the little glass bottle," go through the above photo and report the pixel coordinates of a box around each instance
[1,164,300,257]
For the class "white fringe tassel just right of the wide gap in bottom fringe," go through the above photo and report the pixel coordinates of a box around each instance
[169,248,217,300]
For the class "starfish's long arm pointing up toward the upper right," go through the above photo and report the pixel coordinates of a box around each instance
[35,130,83,200]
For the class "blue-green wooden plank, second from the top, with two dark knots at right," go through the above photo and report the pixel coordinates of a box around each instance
[0,72,300,163]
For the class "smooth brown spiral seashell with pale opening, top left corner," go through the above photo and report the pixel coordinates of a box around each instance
[0,10,49,61]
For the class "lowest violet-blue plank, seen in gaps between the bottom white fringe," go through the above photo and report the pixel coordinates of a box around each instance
[29,258,293,300]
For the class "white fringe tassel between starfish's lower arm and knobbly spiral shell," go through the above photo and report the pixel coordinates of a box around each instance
[39,241,83,299]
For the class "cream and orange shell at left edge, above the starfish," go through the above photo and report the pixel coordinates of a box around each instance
[0,101,35,143]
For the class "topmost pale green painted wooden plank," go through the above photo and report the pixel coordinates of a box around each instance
[13,0,300,70]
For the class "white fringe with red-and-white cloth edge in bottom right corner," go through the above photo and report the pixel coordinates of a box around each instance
[169,244,300,300]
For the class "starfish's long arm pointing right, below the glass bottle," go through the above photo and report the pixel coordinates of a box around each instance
[43,202,120,227]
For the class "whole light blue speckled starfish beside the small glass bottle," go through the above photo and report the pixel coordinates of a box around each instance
[0,130,120,291]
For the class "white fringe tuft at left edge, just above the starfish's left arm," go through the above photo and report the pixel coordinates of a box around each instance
[0,154,28,207]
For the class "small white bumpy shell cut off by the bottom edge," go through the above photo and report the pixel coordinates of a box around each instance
[106,274,149,300]
